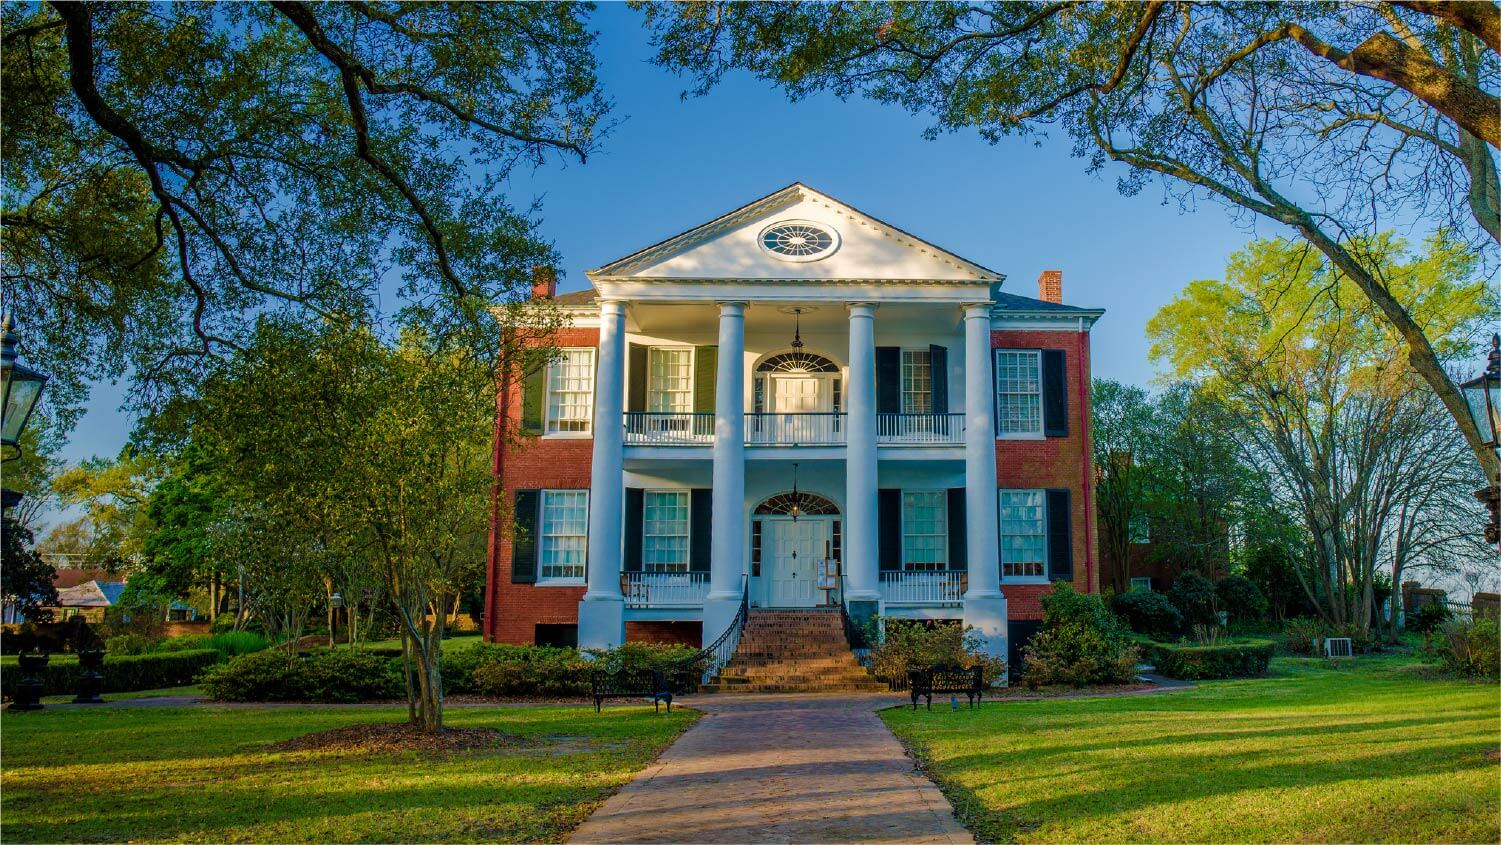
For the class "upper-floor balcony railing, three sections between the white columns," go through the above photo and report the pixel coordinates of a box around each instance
[624,411,964,446]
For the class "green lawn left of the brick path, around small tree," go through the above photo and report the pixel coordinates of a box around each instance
[0,707,696,842]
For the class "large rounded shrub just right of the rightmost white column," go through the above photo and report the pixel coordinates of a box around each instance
[1022,582,1138,689]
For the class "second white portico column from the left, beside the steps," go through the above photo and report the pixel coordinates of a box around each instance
[702,302,746,647]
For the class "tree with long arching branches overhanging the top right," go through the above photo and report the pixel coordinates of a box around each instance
[647,2,1501,483]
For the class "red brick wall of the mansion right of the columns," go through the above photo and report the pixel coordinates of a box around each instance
[991,330,1100,620]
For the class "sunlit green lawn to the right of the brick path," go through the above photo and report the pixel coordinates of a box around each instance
[883,657,1501,842]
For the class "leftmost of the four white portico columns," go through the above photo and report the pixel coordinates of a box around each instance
[578,300,626,648]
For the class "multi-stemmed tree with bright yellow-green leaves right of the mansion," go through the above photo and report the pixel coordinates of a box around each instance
[1147,236,1496,632]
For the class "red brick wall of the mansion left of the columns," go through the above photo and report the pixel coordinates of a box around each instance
[485,329,599,644]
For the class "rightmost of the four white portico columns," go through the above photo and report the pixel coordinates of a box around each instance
[964,303,1006,669]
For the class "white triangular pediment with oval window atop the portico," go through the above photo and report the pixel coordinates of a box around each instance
[588,183,1003,282]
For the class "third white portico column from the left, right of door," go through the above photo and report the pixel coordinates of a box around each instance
[844,302,881,600]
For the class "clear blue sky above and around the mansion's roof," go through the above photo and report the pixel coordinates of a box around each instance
[52,3,1279,462]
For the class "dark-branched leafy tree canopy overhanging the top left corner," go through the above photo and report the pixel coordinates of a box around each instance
[0,2,609,419]
